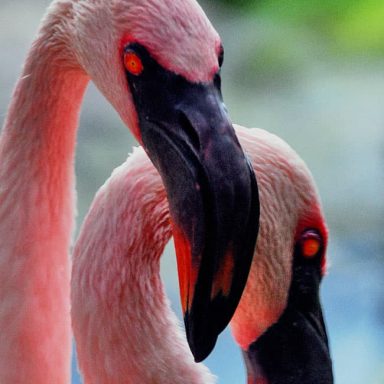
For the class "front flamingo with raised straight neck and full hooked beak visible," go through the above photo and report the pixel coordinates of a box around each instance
[0,0,259,384]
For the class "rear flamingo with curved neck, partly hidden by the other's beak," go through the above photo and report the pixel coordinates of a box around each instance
[72,126,333,384]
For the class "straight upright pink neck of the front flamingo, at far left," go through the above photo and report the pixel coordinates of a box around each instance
[0,39,88,384]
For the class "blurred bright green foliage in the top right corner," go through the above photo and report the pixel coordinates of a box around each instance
[215,0,384,56]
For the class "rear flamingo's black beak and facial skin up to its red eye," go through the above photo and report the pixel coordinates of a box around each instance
[243,230,333,384]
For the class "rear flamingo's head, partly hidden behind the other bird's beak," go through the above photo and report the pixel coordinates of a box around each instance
[231,130,333,384]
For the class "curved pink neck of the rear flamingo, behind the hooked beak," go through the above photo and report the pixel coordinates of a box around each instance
[72,150,213,384]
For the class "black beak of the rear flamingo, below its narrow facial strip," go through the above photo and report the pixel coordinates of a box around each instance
[243,308,333,384]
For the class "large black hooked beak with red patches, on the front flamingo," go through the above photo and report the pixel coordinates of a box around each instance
[125,43,259,361]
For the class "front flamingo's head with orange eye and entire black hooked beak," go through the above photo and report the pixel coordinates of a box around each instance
[72,0,259,361]
